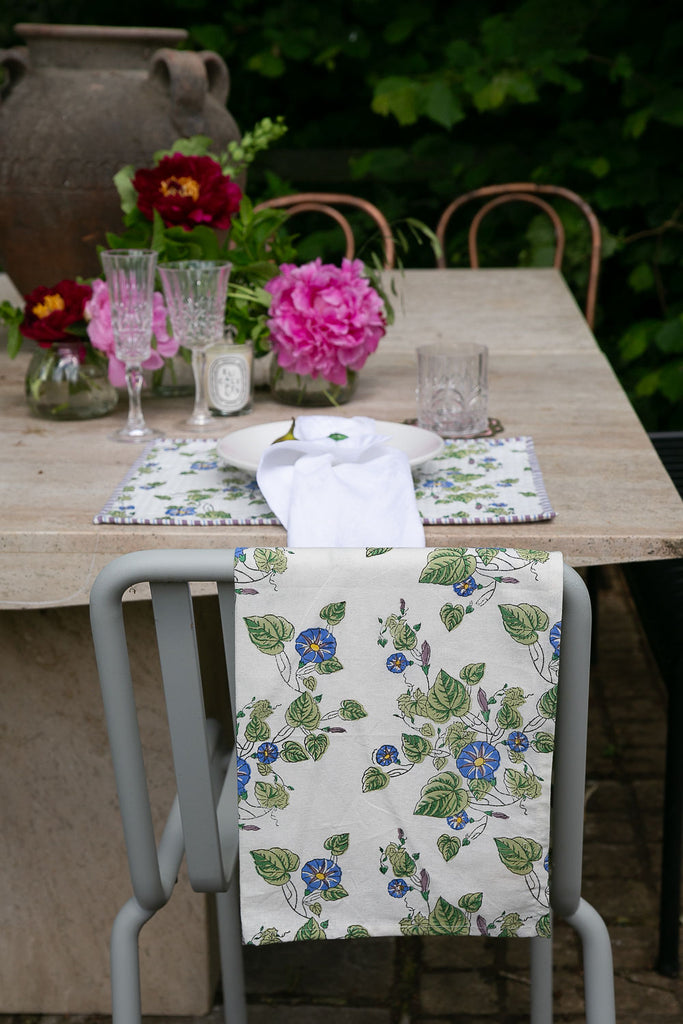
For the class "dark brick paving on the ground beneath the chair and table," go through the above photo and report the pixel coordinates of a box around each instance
[0,569,683,1024]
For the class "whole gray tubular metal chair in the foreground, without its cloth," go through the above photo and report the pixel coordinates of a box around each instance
[90,550,614,1024]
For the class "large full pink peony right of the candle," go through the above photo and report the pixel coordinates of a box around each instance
[265,258,386,386]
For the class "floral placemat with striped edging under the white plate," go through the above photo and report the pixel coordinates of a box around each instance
[93,437,555,526]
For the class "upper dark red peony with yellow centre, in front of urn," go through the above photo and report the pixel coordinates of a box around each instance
[133,153,242,230]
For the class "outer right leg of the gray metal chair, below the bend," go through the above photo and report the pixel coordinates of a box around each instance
[564,899,616,1024]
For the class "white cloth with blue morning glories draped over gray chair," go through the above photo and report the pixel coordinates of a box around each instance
[234,548,562,945]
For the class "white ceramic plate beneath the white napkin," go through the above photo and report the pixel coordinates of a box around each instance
[218,420,443,473]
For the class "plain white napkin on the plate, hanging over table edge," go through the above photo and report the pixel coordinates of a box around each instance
[256,416,425,548]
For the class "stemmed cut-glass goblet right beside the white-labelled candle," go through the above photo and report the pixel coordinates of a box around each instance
[159,260,232,428]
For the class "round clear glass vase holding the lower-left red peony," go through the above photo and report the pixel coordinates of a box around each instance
[26,340,119,420]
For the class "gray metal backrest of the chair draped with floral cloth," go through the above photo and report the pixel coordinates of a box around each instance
[90,550,591,916]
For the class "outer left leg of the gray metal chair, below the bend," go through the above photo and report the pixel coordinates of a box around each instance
[110,898,154,1024]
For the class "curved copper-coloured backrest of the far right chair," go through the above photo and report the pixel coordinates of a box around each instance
[436,181,601,330]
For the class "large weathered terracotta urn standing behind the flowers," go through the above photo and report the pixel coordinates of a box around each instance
[0,25,240,294]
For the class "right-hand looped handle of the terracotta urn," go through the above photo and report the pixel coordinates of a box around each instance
[150,47,230,136]
